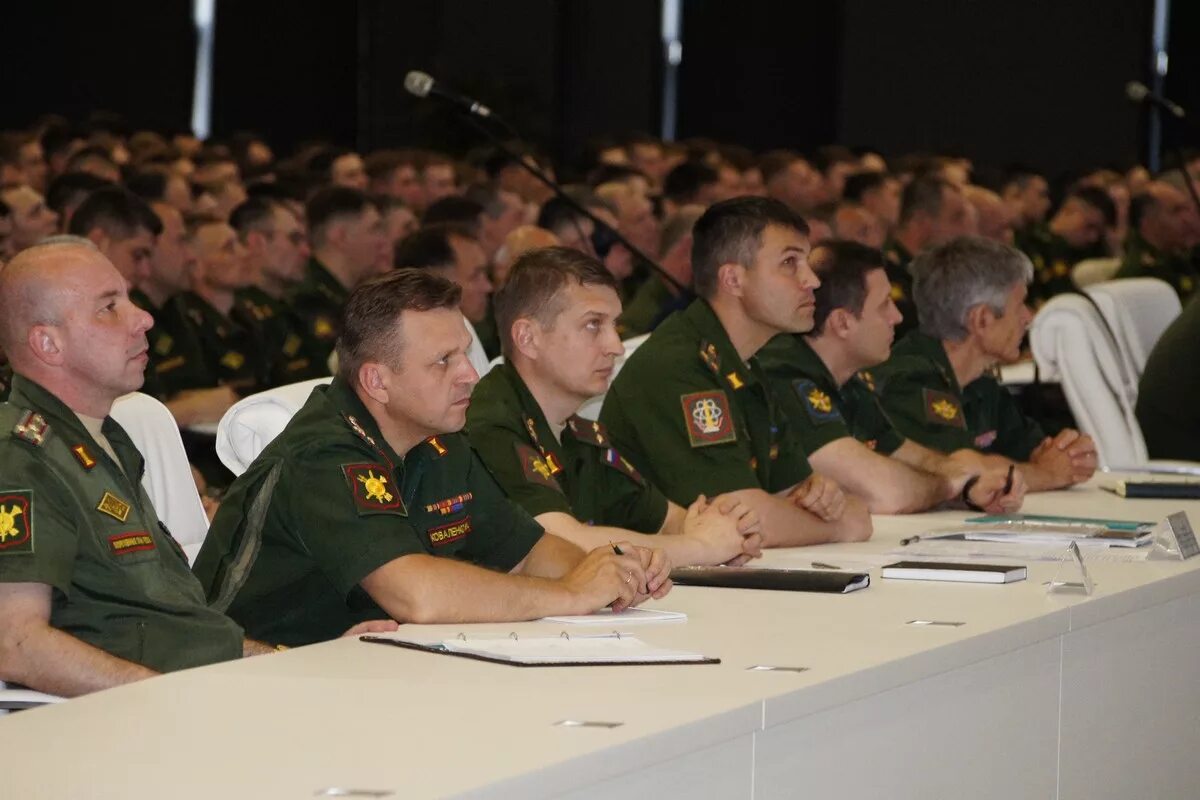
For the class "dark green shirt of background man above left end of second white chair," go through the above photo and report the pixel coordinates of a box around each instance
[172,291,266,395]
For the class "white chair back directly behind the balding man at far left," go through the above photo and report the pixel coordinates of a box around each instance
[112,392,209,561]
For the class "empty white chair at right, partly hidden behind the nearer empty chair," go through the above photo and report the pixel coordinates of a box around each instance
[1086,278,1181,380]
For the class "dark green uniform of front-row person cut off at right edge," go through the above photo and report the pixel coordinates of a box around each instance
[1136,297,1200,461]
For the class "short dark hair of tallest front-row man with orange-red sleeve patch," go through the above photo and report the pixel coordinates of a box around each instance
[691,197,809,297]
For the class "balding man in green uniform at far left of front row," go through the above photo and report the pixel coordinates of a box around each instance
[0,243,249,696]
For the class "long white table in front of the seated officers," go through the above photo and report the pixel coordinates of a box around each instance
[0,479,1200,800]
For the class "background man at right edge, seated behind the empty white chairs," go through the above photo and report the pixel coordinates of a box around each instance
[1116,181,1200,302]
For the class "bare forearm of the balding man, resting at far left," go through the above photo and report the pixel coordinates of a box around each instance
[0,625,158,697]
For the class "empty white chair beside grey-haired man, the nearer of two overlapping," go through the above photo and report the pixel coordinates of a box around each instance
[1030,295,1147,467]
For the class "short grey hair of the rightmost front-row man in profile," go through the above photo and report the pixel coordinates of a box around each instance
[910,236,1033,342]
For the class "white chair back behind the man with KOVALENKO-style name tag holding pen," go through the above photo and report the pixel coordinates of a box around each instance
[217,378,332,475]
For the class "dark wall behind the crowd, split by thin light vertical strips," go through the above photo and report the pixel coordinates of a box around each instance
[0,0,1180,172]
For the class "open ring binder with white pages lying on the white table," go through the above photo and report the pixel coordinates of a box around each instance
[360,632,721,667]
